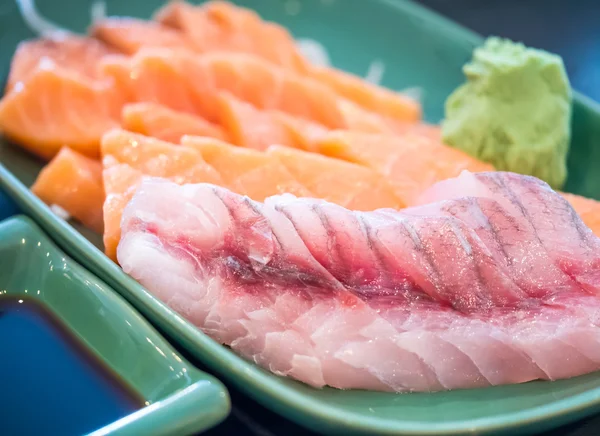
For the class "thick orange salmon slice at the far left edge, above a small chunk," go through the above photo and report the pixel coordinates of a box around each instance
[0,61,123,159]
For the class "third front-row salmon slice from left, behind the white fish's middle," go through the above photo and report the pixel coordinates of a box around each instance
[266,146,404,210]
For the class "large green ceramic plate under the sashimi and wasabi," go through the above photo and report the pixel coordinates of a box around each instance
[0,0,600,435]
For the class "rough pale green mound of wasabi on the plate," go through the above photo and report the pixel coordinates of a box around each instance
[442,37,572,189]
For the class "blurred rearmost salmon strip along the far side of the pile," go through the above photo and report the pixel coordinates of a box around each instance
[156,1,421,122]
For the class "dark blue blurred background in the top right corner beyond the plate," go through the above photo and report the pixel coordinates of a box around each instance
[419,0,600,103]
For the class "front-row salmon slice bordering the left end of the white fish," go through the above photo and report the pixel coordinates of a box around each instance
[102,129,222,260]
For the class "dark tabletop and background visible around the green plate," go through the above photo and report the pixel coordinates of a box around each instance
[205,0,600,436]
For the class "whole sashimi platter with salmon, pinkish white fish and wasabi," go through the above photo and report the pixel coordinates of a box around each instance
[0,0,600,434]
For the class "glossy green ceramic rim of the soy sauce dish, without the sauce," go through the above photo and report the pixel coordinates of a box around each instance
[0,217,229,435]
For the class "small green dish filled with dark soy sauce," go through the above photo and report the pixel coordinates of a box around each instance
[0,216,229,436]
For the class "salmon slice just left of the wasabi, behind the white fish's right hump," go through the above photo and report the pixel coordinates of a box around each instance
[317,131,492,205]
